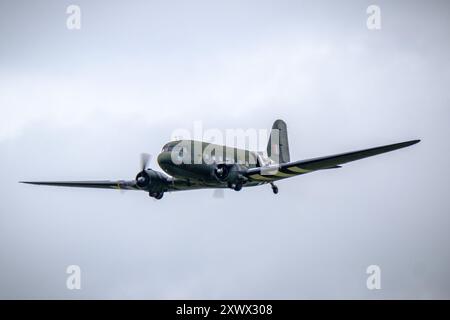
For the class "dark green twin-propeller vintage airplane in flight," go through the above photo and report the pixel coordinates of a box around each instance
[20,120,420,200]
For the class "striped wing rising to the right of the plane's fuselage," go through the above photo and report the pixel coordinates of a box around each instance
[246,140,420,182]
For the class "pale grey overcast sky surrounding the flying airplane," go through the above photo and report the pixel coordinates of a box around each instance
[0,0,450,299]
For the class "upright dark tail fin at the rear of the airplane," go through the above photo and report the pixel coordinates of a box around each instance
[267,120,291,163]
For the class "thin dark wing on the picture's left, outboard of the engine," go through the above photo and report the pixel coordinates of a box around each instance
[20,180,141,190]
